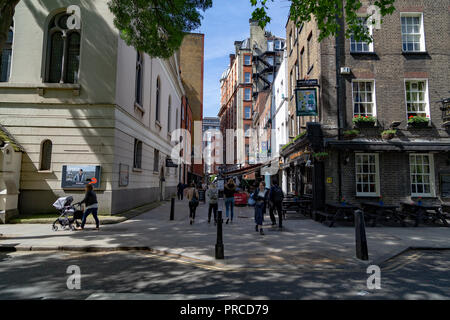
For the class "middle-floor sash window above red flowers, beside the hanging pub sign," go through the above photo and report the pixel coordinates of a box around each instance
[352,81,376,117]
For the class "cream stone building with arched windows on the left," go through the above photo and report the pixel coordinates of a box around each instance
[0,0,201,220]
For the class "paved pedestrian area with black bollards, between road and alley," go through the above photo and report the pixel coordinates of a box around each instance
[0,201,450,271]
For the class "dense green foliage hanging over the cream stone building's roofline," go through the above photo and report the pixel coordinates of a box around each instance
[108,0,212,58]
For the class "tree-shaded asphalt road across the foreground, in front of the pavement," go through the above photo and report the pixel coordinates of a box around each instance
[0,250,450,299]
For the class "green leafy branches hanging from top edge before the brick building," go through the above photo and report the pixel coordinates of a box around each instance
[250,0,395,42]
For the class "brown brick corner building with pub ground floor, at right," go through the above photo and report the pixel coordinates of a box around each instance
[281,0,450,208]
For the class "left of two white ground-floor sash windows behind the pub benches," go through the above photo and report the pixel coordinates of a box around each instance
[355,153,380,196]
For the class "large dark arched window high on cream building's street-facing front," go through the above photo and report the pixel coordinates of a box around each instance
[45,12,81,83]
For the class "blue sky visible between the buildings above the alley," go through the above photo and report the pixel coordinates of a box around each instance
[195,0,290,117]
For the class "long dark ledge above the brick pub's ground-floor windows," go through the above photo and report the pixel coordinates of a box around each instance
[326,140,450,152]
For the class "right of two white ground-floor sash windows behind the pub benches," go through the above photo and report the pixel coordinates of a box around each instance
[409,154,434,197]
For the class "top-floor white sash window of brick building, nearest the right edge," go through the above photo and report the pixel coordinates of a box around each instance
[401,13,425,52]
